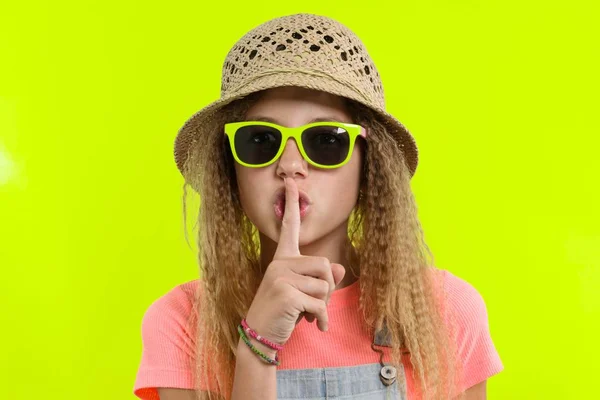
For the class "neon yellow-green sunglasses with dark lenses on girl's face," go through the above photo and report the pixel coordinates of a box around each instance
[225,121,367,168]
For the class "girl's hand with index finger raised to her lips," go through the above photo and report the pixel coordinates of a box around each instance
[246,178,346,344]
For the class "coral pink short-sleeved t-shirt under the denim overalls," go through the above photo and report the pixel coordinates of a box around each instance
[134,270,504,400]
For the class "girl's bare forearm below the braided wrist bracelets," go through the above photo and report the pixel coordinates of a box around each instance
[231,338,277,400]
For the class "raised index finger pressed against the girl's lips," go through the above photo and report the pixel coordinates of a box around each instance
[275,178,300,258]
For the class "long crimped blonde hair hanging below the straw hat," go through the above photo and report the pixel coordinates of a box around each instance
[183,93,458,400]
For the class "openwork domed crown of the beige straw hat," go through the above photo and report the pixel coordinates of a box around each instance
[221,14,385,109]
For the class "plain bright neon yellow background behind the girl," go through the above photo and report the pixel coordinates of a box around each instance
[0,0,600,400]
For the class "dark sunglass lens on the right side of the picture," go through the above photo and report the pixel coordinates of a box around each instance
[302,126,350,165]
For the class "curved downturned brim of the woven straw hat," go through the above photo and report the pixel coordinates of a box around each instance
[175,71,418,176]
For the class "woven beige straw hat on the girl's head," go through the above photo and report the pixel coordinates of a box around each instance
[175,14,418,181]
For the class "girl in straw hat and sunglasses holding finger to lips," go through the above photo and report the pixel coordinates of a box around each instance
[134,14,503,400]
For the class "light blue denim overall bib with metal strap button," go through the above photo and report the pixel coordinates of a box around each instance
[277,327,406,400]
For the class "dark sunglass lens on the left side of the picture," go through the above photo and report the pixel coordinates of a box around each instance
[234,125,281,164]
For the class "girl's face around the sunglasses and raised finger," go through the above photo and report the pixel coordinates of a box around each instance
[235,87,364,246]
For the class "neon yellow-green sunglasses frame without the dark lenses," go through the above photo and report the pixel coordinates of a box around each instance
[225,121,367,169]
